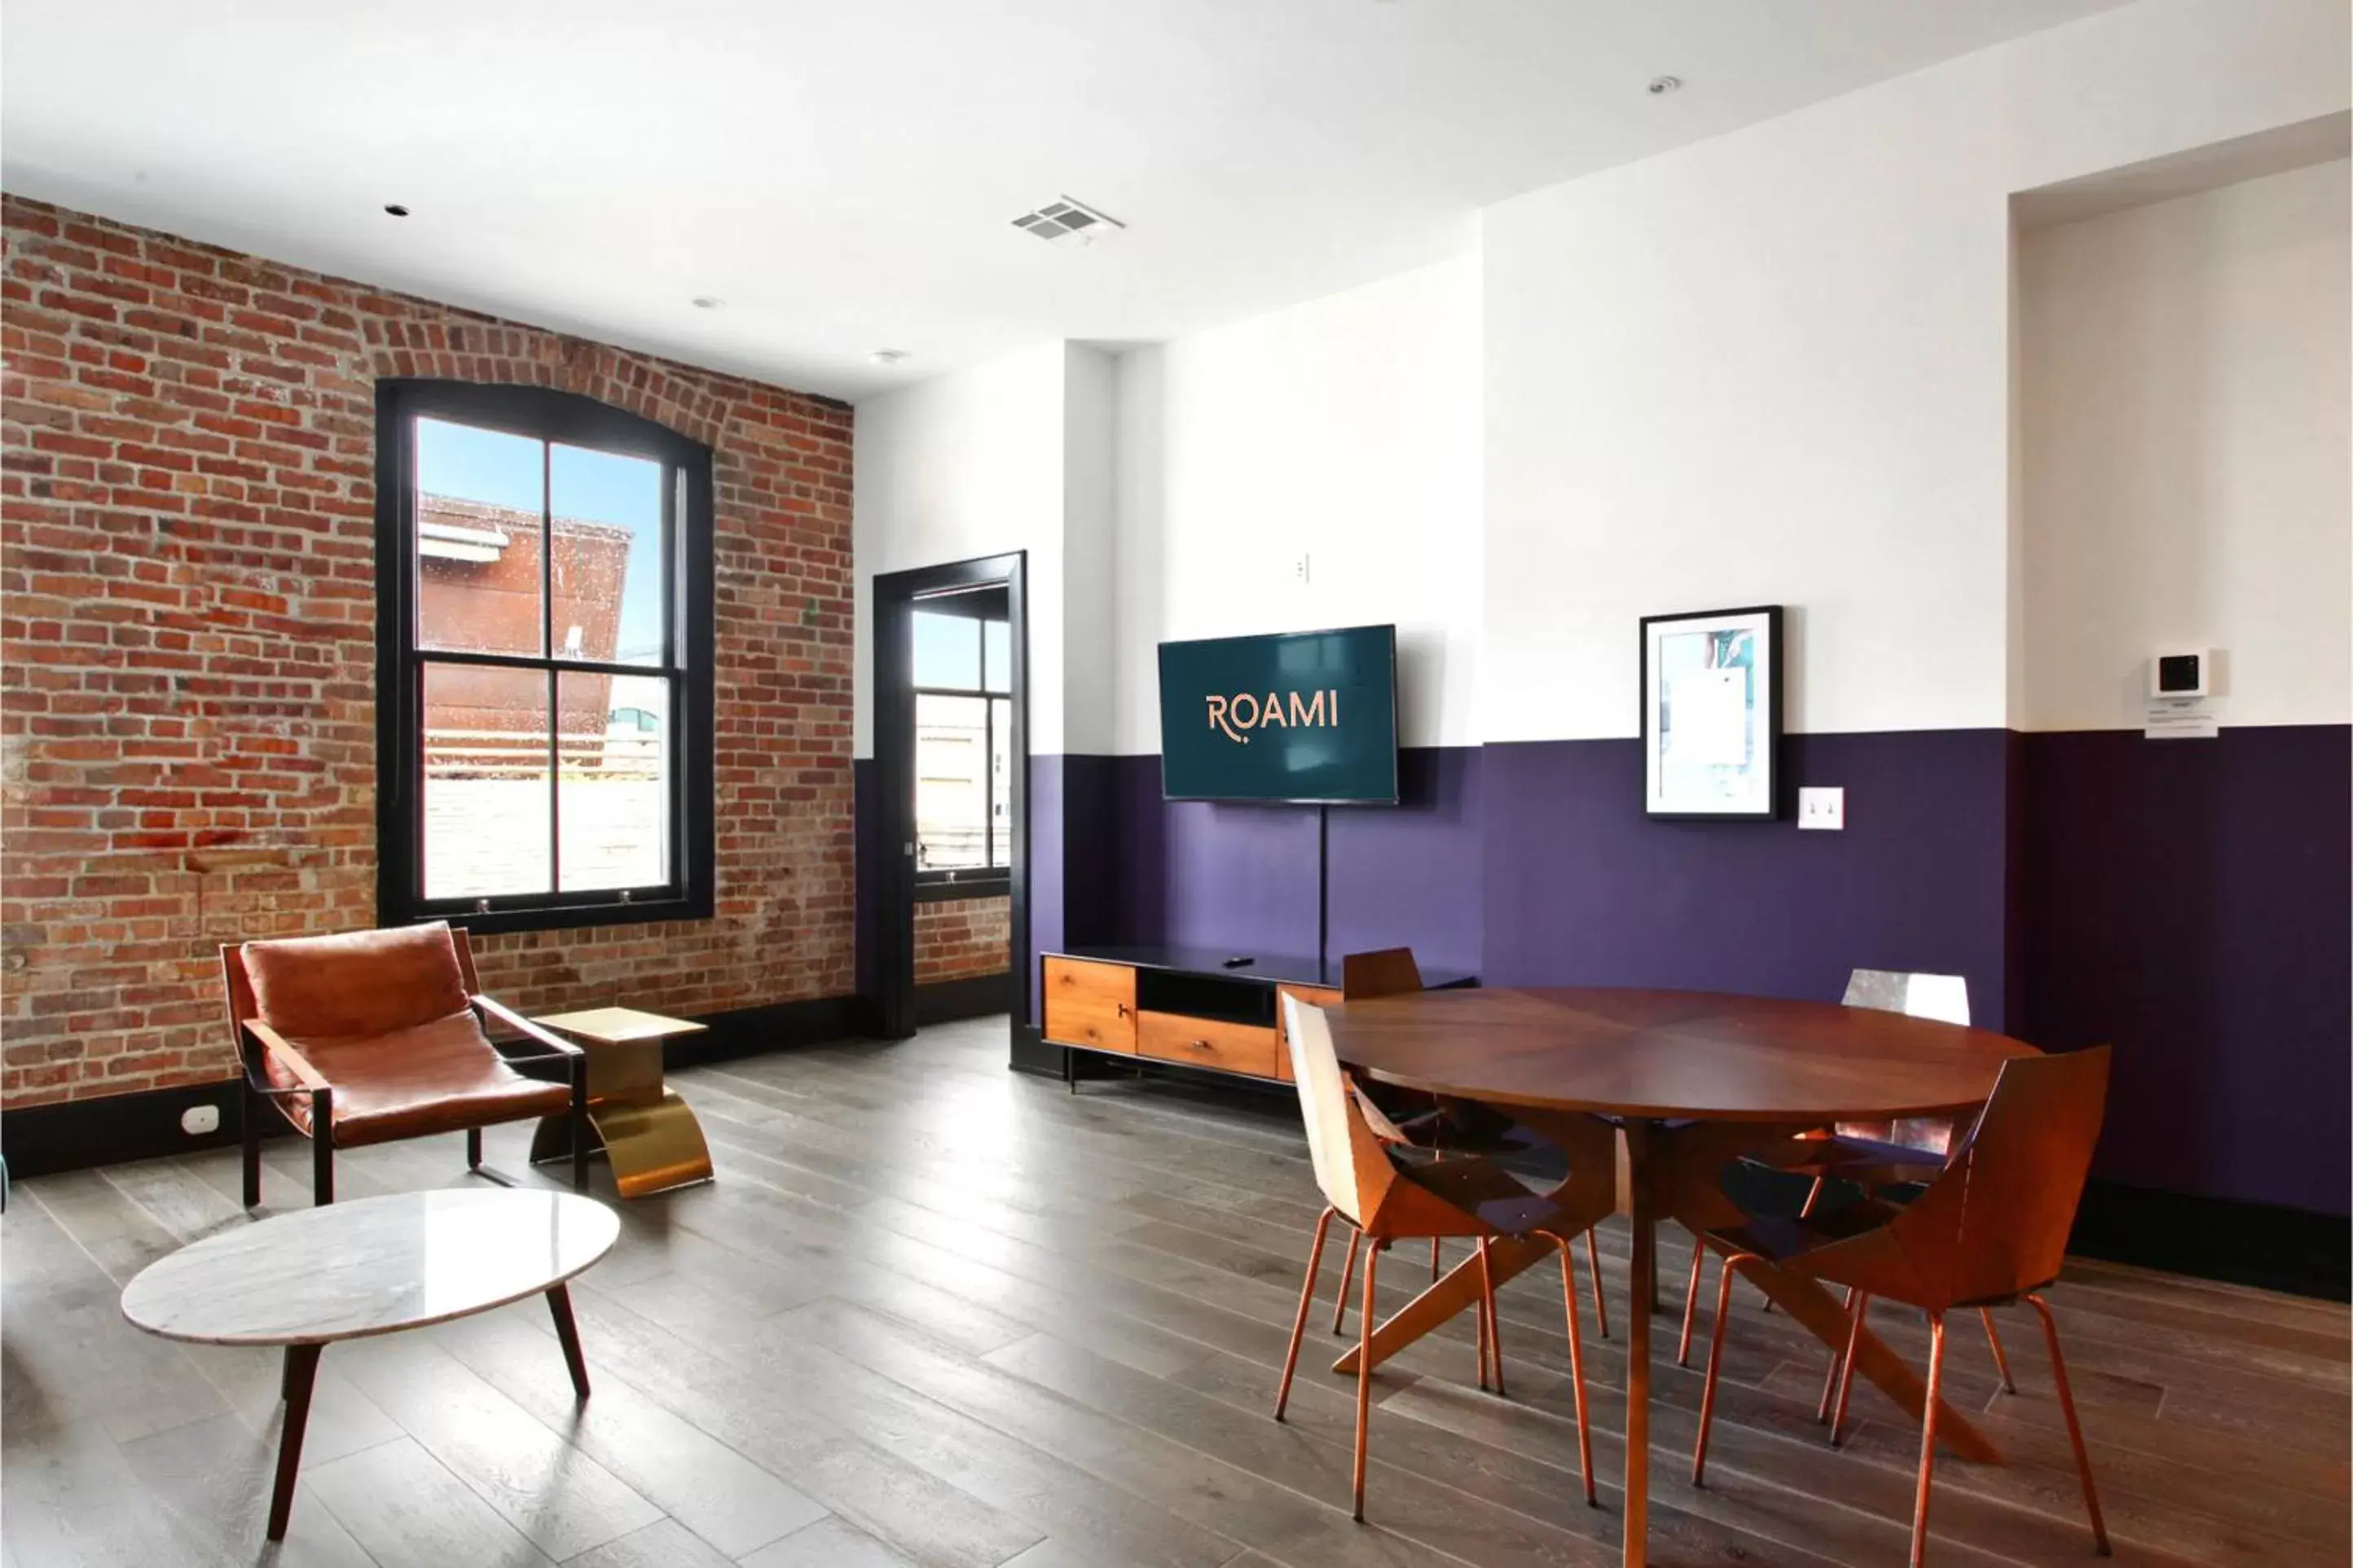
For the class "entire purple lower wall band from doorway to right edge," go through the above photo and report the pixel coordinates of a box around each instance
[880,727,2353,1215]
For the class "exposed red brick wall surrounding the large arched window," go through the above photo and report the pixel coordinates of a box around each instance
[0,197,854,1105]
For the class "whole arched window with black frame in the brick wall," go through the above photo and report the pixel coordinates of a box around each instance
[376,381,713,931]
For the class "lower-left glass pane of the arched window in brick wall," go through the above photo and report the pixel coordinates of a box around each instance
[424,665,548,898]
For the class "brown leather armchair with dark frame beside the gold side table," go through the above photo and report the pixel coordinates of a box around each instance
[221,921,588,1208]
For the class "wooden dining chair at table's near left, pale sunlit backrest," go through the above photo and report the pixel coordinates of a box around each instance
[1275,995,1598,1521]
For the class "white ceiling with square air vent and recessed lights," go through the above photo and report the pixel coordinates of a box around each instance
[0,0,2118,397]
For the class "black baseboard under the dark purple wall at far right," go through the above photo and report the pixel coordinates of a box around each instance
[2069,1183,2353,1302]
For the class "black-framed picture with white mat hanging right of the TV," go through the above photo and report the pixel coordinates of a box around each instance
[1643,604,1781,823]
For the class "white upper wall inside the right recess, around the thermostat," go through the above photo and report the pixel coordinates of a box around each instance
[2019,160,2353,729]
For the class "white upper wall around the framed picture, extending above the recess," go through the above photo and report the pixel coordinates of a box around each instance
[1480,0,2353,740]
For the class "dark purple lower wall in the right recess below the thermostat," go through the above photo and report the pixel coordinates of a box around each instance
[2019,724,2353,1213]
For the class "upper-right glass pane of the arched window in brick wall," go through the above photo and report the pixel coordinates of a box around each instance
[548,444,668,665]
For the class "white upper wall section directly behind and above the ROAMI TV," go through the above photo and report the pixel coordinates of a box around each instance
[1115,257,1482,753]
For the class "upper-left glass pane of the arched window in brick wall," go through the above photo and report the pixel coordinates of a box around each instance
[416,419,546,658]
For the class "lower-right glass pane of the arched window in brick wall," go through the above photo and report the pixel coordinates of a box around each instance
[556,670,671,894]
